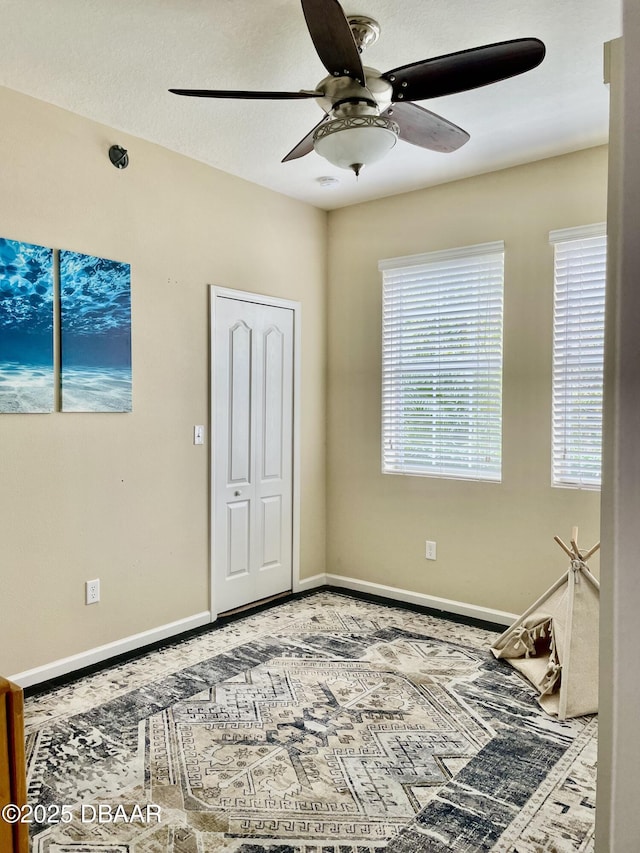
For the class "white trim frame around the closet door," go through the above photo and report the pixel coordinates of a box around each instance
[209,285,302,621]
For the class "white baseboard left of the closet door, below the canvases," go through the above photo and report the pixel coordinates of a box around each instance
[9,610,211,687]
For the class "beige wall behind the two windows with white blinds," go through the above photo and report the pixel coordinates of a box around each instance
[327,148,607,612]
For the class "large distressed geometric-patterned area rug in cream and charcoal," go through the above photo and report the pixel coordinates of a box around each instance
[26,592,596,853]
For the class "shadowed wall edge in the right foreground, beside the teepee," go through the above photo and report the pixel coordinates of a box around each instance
[595,13,640,853]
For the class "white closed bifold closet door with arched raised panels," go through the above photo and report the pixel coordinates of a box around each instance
[212,296,293,613]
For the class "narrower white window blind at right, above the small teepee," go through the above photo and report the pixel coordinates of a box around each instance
[549,224,607,488]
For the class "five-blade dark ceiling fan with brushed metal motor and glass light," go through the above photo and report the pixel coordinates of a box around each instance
[169,0,545,175]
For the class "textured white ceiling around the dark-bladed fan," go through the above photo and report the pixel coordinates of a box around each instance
[0,0,621,209]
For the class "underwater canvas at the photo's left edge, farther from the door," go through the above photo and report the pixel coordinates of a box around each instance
[0,237,54,414]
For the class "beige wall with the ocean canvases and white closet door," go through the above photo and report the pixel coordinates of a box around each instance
[0,89,326,675]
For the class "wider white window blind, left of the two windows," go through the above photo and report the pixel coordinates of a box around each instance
[379,242,504,481]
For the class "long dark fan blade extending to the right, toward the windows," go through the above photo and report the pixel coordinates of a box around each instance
[381,38,545,101]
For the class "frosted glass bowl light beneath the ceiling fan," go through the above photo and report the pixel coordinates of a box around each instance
[313,115,400,175]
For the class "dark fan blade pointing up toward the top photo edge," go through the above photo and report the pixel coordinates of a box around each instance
[302,0,364,83]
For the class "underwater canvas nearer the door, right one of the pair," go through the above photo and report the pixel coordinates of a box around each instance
[60,251,131,412]
